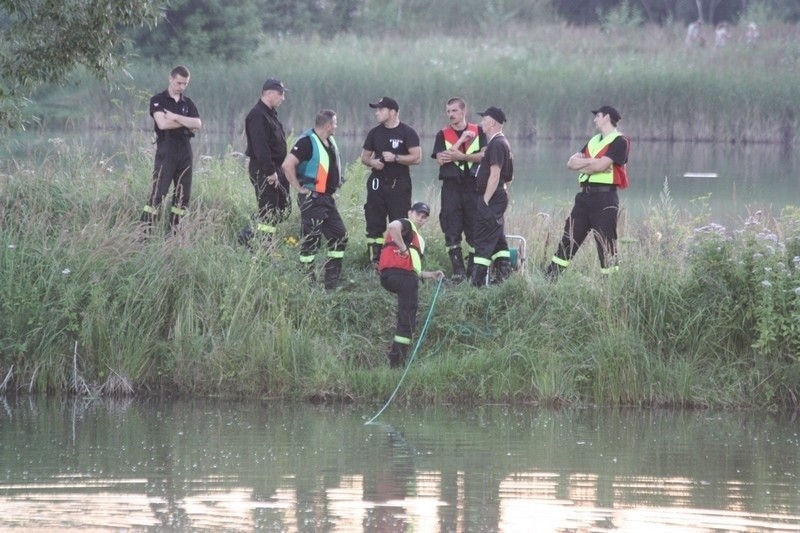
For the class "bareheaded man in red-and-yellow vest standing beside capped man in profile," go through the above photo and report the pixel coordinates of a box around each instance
[431,96,486,281]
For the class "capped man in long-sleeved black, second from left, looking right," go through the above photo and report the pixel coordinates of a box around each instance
[238,78,291,244]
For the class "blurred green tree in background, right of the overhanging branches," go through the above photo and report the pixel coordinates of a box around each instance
[135,0,262,60]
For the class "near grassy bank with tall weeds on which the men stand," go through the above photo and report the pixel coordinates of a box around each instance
[0,144,800,408]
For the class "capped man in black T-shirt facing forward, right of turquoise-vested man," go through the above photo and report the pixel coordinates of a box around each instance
[361,96,422,264]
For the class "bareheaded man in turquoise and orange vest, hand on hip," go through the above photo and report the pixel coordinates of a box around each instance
[283,109,347,289]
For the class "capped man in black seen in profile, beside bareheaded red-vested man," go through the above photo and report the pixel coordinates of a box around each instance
[470,106,514,287]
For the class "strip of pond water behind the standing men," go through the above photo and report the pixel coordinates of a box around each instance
[0,132,800,225]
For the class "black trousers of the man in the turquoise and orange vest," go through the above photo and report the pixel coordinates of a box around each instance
[297,193,347,263]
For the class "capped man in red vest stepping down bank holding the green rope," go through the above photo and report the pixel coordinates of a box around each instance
[378,202,444,368]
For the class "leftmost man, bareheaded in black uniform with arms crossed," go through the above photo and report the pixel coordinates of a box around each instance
[140,66,202,233]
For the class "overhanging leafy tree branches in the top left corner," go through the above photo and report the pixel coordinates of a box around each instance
[0,0,159,128]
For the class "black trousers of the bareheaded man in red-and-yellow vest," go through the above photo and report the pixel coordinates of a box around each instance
[439,178,475,249]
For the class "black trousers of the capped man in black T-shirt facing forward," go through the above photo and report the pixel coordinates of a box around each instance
[364,174,411,242]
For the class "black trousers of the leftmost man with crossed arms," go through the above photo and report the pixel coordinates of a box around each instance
[147,138,192,211]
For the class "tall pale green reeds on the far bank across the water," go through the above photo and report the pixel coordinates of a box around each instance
[28,24,800,144]
